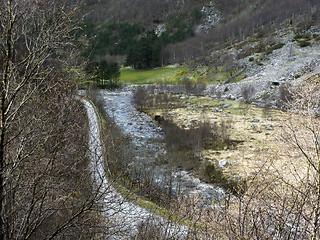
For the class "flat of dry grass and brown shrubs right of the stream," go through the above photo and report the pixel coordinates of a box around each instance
[135,89,282,187]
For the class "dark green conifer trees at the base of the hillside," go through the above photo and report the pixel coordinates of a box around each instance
[79,9,201,69]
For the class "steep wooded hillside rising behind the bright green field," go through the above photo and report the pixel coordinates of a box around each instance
[83,0,320,77]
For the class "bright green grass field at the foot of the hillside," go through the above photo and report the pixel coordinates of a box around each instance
[120,67,188,84]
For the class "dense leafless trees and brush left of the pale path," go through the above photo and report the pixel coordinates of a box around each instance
[0,0,111,240]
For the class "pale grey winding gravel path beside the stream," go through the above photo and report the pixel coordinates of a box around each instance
[81,98,186,239]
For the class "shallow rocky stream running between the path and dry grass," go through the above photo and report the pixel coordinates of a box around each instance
[84,89,226,201]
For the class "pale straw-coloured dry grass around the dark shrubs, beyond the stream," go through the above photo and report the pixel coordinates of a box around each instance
[147,94,285,181]
